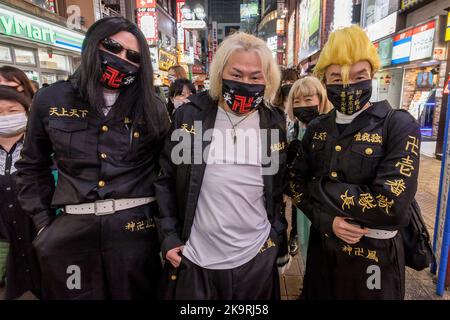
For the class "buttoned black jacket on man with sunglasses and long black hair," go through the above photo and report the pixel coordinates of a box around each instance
[16,81,170,229]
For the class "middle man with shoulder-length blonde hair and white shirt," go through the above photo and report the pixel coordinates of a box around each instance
[155,33,286,300]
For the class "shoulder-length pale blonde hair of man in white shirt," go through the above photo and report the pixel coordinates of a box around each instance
[209,32,280,102]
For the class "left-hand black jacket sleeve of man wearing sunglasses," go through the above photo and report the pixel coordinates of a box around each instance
[16,90,55,230]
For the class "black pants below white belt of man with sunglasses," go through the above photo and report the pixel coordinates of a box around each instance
[34,204,162,299]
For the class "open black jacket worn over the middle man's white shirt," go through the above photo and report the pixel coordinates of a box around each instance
[155,92,287,256]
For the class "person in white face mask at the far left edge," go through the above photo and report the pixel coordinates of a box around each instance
[0,86,39,299]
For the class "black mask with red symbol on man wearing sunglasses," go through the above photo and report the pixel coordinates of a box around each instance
[99,50,139,90]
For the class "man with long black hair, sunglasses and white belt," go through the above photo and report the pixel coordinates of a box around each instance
[17,17,169,299]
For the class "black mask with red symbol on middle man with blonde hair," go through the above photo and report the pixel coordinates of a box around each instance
[222,79,266,114]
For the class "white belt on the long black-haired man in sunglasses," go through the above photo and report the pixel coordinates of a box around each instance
[64,197,156,216]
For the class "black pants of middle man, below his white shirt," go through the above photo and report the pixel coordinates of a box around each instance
[162,230,280,300]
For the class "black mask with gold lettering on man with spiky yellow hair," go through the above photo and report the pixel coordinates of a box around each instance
[327,80,372,116]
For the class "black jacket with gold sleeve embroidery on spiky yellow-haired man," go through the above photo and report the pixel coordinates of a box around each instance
[287,101,420,235]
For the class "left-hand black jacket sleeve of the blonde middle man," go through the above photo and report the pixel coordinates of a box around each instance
[154,112,184,258]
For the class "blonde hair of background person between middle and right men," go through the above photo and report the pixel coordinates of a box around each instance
[286,76,331,119]
